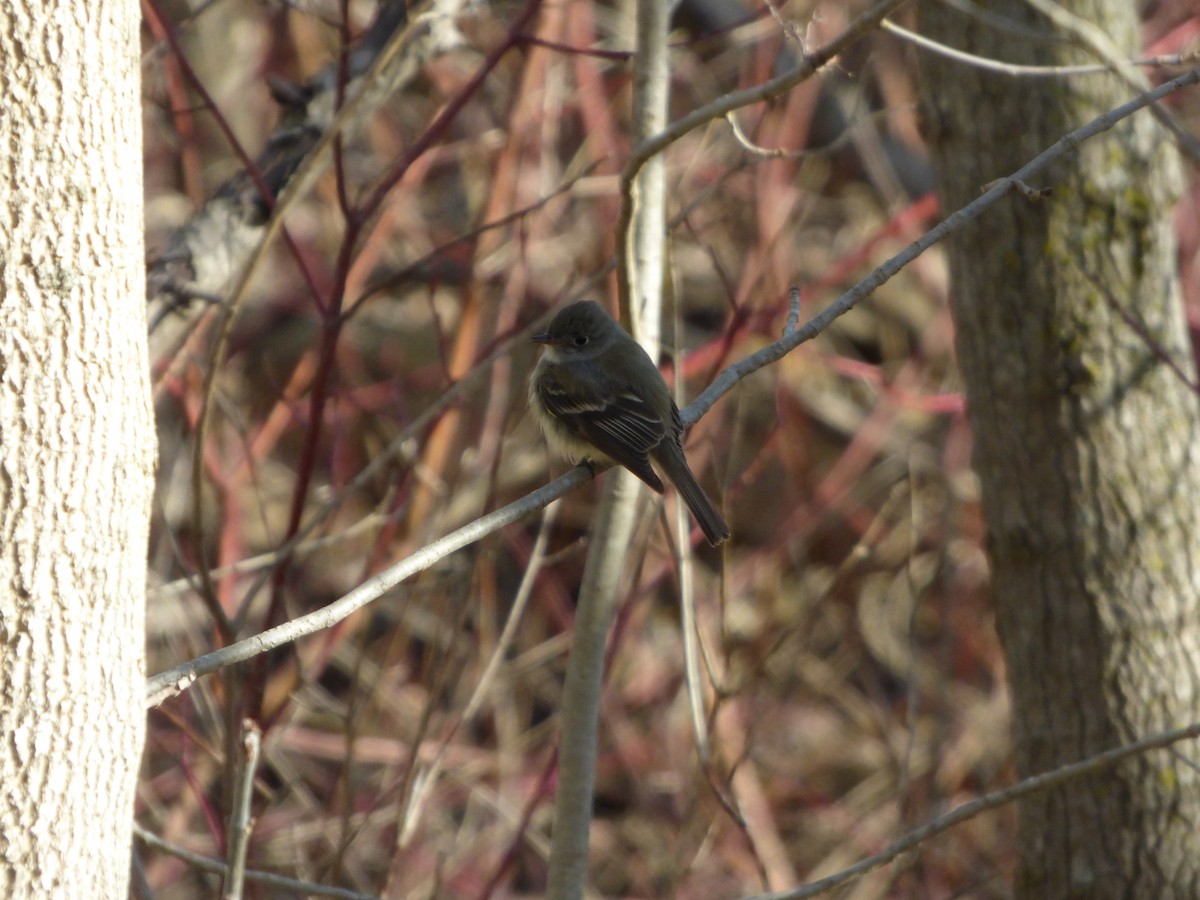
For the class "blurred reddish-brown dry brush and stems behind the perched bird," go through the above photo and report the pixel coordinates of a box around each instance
[138,0,1200,900]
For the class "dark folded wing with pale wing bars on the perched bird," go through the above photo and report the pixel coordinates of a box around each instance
[538,378,666,493]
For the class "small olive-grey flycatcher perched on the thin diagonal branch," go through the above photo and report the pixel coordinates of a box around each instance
[529,301,730,546]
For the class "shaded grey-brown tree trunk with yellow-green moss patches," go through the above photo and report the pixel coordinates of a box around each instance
[922,0,1200,898]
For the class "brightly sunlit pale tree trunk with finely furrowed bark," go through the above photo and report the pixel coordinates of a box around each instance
[0,0,154,898]
